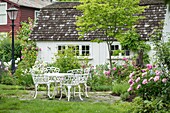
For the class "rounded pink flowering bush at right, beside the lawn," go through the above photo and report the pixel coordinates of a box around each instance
[128,64,170,100]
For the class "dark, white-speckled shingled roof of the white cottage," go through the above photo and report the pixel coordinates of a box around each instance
[31,0,166,41]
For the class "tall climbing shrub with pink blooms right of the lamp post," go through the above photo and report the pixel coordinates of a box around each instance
[15,18,41,79]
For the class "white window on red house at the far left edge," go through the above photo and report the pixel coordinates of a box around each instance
[0,2,7,25]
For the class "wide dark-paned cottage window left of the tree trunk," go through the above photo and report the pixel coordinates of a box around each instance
[58,45,90,56]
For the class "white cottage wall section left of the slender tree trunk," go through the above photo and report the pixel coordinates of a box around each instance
[37,41,108,65]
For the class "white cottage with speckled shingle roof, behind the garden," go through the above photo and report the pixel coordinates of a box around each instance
[31,0,170,65]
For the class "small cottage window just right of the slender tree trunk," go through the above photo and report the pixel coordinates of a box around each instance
[111,45,130,56]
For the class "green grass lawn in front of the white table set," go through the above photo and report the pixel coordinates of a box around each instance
[0,84,131,113]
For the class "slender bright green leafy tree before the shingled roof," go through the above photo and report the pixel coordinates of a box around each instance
[76,0,145,68]
